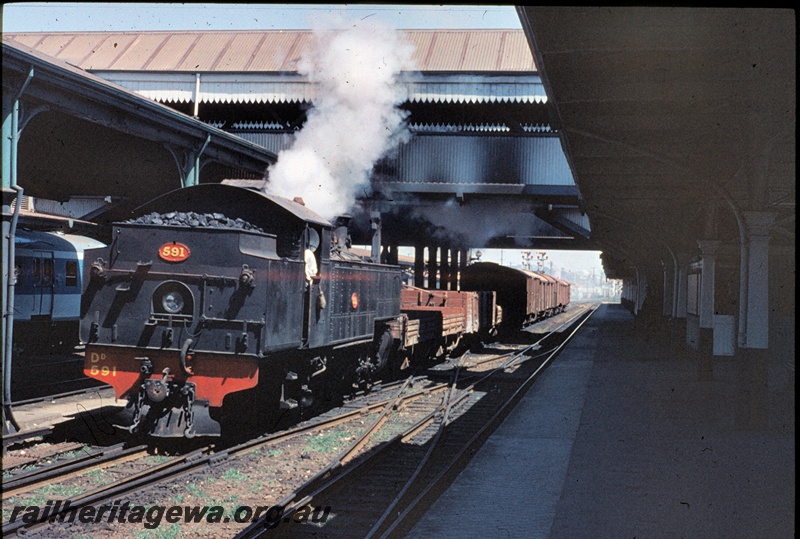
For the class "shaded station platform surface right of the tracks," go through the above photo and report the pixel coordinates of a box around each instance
[408,304,795,539]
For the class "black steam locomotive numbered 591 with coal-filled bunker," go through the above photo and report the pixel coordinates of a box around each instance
[81,184,460,437]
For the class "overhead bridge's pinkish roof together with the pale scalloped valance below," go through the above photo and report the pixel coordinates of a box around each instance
[3,30,547,103]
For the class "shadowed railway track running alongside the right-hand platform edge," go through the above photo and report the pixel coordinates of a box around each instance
[237,304,594,539]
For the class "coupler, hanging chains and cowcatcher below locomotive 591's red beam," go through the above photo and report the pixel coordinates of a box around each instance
[120,376,221,438]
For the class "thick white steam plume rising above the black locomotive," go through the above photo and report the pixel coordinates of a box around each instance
[266,21,414,220]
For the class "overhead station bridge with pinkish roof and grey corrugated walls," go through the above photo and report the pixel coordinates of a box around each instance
[4,30,592,252]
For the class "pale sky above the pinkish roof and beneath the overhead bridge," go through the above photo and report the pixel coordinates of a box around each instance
[3,2,602,280]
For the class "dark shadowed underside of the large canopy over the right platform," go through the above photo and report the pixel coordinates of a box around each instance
[517,6,797,277]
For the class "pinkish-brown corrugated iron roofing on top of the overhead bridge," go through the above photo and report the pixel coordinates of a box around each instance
[3,30,536,73]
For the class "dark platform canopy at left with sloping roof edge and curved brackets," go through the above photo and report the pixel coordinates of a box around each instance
[3,41,276,215]
